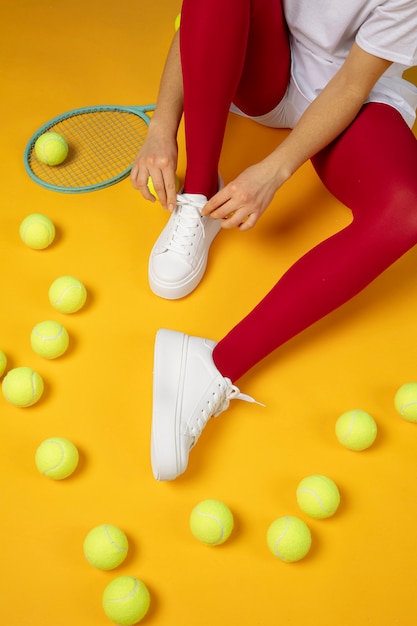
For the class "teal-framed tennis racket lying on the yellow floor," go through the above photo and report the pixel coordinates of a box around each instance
[24,104,155,193]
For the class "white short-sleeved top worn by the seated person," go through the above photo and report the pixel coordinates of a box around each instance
[284,0,417,126]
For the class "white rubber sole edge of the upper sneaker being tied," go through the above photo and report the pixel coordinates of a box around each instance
[148,218,221,300]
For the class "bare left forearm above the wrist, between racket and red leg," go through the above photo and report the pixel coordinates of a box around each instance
[149,31,184,136]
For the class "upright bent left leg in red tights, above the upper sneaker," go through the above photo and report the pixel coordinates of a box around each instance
[180,0,290,198]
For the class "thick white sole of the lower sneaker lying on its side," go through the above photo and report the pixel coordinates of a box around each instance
[151,329,186,480]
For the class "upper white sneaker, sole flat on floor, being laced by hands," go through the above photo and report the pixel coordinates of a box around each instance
[148,193,221,300]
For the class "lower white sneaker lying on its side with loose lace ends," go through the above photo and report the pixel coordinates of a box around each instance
[151,329,258,480]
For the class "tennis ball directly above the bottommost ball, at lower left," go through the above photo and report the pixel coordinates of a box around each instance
[84,524,128,570]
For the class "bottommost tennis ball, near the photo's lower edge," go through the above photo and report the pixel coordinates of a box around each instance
[103,576,151,626]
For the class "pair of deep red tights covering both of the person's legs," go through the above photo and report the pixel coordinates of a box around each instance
[181,0,417,381]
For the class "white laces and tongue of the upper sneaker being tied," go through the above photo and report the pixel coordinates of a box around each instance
[166,195,206,256]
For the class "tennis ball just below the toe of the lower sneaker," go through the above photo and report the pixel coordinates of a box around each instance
[190,500,233,546]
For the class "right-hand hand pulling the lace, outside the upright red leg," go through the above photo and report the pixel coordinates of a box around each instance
[202,162,279,230]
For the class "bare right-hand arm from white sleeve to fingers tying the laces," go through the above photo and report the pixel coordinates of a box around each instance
[203,44,391,230]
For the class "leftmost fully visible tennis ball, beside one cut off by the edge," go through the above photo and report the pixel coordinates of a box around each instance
[2,367,43,408]
